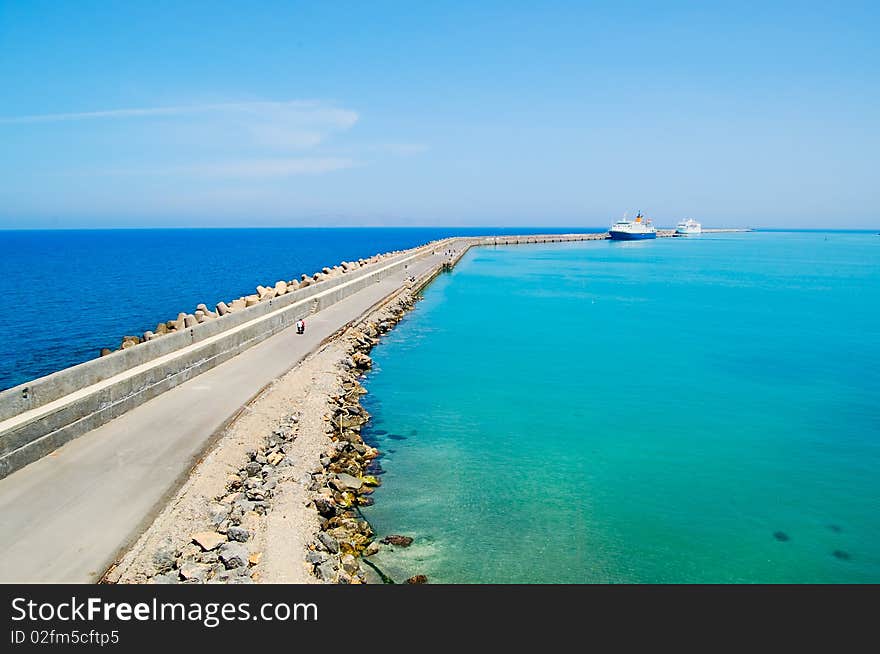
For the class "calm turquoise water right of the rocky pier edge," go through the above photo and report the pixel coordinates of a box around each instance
[364,232,880,583]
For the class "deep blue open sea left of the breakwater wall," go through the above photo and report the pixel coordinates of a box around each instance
[0,227,604,390]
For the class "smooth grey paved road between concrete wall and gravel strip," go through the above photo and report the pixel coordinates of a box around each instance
[0,254,454,583]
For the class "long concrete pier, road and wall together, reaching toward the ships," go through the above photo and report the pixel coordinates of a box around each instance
[0,233,744,583]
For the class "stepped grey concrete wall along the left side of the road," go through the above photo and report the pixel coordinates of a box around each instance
[0,241,464,478]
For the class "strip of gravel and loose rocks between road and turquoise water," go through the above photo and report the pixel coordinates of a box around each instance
[103,270,438,584]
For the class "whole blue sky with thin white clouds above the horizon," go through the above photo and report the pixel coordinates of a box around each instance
[0,0,880,229]
